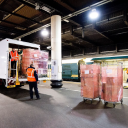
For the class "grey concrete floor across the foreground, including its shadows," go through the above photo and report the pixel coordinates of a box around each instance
[0,82,128,128]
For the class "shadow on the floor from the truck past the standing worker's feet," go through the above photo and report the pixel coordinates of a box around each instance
[0,88,56,111]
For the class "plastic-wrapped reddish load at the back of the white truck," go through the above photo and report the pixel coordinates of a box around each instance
[22,49,49,77]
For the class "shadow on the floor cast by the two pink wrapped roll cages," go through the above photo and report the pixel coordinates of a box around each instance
[69,100,128,126]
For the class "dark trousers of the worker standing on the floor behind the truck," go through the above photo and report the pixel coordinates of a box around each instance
[29,82,40,99]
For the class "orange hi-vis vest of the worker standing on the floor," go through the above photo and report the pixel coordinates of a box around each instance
[27,68,36,82]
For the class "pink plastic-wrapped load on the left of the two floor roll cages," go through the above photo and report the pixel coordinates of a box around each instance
[80,64,100,99]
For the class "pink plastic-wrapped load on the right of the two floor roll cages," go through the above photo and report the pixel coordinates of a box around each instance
[102,64,123,102]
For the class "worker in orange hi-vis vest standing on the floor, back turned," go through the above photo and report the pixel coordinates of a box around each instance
[26,64,40,100]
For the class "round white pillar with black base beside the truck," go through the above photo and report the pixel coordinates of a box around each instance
[51,15,63,87]
